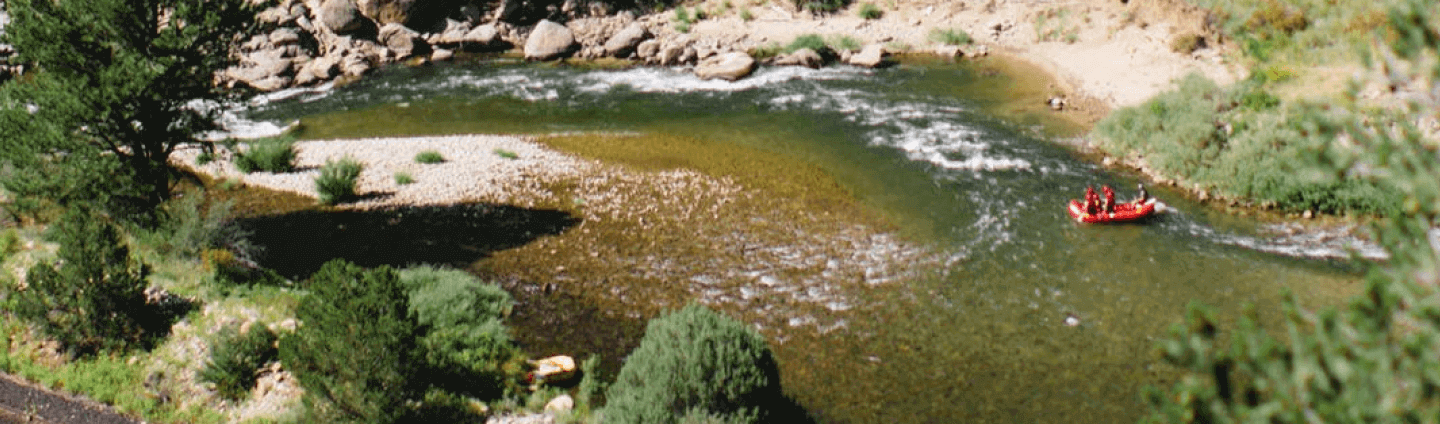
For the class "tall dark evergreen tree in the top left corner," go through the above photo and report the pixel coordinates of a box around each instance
[0,0,253,218]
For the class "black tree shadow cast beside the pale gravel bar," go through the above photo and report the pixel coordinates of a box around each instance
[236,203,580,280]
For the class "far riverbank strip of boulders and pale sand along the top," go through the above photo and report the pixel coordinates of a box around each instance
[220,0,1236,121]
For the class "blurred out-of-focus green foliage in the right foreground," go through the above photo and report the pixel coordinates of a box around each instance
[1146,0,1440,423]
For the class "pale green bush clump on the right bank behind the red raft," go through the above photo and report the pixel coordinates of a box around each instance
[1093,75,1397,213]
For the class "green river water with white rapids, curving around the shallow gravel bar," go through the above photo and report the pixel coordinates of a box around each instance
[245,59,1358,423]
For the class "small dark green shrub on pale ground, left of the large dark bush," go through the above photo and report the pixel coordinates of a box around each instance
[200,324,279,399]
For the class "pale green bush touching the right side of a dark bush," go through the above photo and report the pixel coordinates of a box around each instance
[400,267,523,398]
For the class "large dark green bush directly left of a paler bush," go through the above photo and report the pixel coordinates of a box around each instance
[279,260,420,423]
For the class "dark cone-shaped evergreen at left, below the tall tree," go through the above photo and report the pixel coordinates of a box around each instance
[14,208,161,355]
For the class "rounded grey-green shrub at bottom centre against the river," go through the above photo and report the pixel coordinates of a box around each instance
[603,306,783,424]
